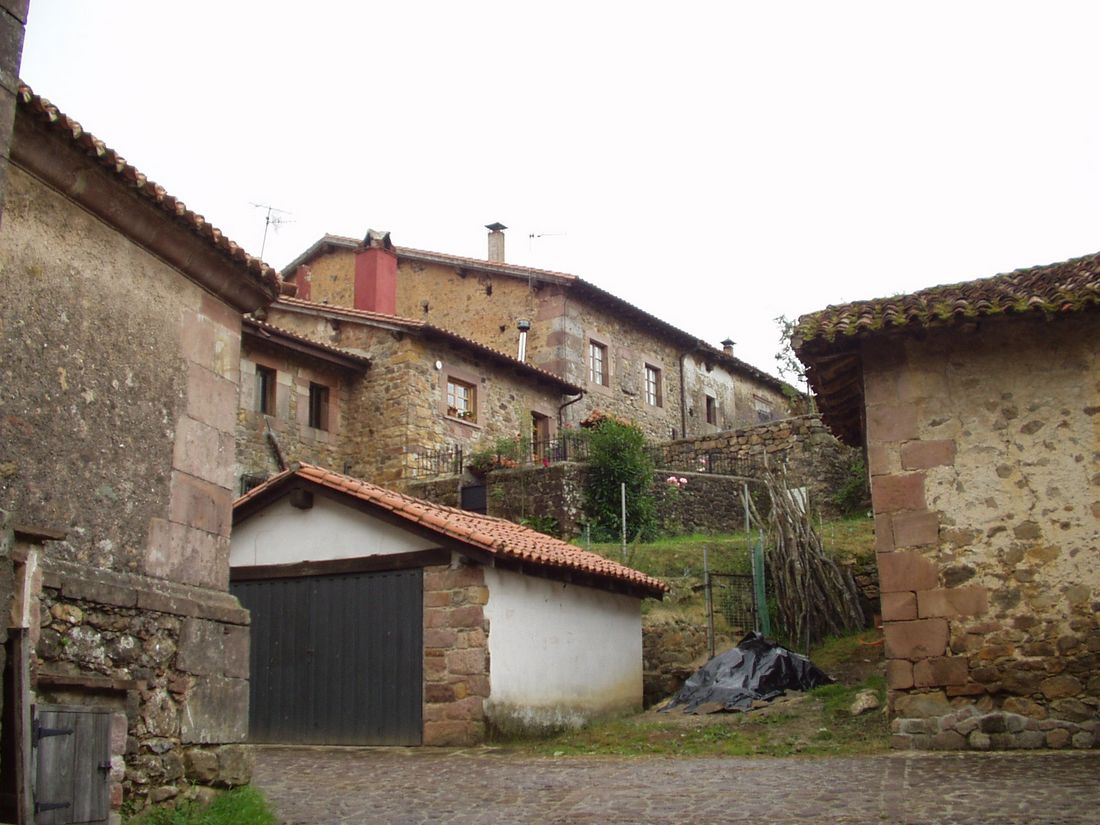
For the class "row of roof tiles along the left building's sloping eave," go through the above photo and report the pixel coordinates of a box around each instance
[17,83,279,292]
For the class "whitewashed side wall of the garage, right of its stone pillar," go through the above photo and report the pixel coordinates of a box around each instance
[485,568,641,732]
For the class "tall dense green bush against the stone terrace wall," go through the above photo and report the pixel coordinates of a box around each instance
[584,418,657,541]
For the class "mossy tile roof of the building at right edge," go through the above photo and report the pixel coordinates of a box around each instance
[795,253,1100,350]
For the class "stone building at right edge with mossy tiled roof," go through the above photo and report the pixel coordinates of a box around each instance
[795,255,1100,749]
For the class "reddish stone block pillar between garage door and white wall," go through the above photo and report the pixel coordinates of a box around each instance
[424,557,490,746]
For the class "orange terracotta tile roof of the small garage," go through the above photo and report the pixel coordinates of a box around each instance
[233,464,669,597]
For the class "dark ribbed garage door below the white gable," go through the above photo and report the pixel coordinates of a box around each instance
[231,568,424,745]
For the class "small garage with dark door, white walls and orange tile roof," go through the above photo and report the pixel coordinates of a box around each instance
[230,464,666,745]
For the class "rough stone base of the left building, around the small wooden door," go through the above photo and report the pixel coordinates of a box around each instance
[31,559,252,807]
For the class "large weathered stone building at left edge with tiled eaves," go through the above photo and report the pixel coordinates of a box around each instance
[0,87,279,822]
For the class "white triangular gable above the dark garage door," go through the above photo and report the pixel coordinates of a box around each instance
[229,495,439,568]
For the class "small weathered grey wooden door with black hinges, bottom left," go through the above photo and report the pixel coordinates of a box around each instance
[31,705,111,825]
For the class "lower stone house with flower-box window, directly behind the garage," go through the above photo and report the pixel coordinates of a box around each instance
[238,283,581,486]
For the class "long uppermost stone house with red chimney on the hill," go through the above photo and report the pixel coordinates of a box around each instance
[283,224,788,441]
